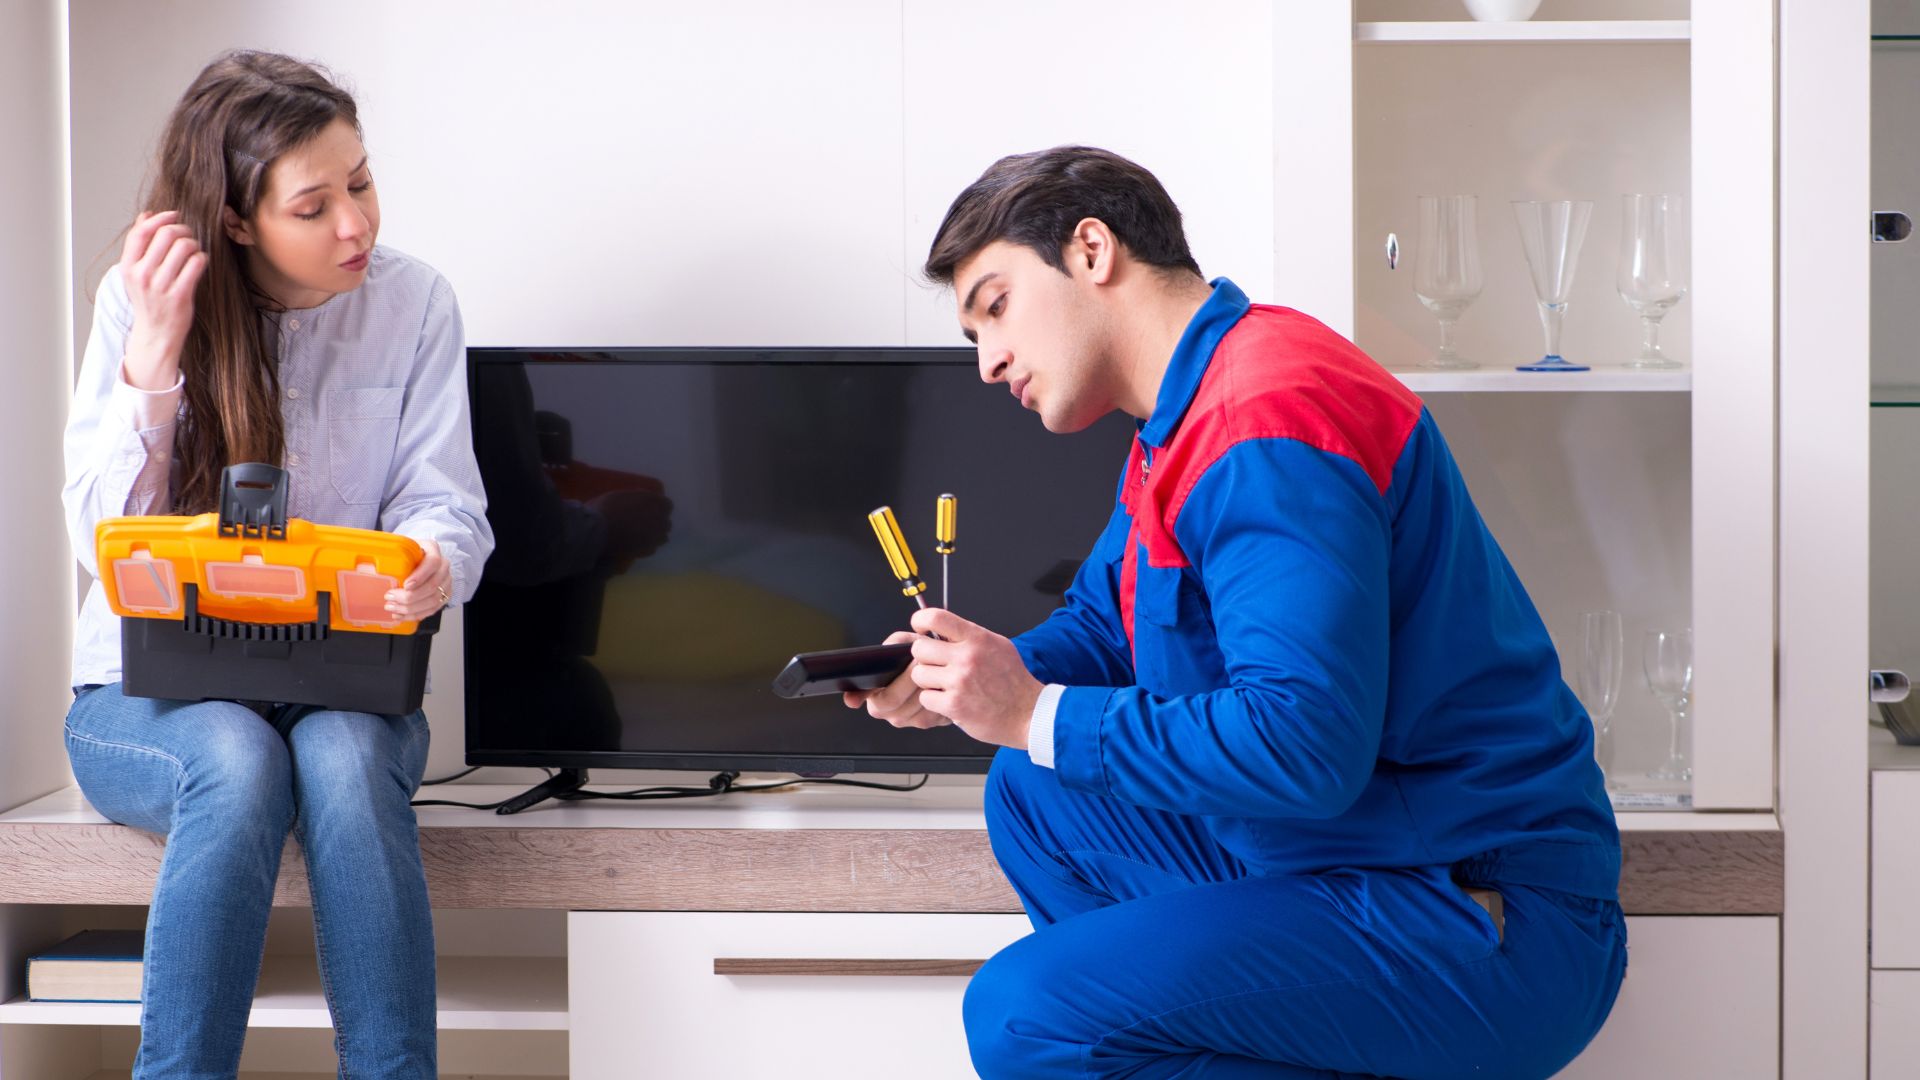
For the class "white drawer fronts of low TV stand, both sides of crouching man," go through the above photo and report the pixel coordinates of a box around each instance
[568,911,1780,1080]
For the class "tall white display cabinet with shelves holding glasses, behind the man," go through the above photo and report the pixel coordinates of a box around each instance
[1336,0,1776,811]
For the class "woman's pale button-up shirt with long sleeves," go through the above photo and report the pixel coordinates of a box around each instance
[61,248,493,686]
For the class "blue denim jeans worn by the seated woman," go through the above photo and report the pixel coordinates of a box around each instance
[67,682,436,1080]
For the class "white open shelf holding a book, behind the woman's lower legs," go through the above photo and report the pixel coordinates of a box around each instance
[0,957,566,1032]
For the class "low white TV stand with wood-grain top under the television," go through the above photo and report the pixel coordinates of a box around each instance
[0,776,1784,1080]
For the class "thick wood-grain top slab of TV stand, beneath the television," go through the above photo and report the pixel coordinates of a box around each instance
[0,778,1786,910]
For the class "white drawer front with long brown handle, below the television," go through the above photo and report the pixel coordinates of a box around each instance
[566,911,1029,1080]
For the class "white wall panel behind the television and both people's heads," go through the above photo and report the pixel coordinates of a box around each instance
[71,0,1282,771]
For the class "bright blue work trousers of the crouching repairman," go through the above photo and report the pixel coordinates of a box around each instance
[966,749,1626,1080]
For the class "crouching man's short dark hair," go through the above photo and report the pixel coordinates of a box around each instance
[925,146,1200,286]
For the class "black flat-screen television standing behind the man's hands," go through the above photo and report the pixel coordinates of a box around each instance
[465,348,1133,773]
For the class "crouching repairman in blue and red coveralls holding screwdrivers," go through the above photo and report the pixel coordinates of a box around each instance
[847,146,1626,1078]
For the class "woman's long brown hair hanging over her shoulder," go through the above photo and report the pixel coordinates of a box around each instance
[146,52,359,513]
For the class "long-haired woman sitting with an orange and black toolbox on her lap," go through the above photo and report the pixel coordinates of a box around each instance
[63,52,493,1080]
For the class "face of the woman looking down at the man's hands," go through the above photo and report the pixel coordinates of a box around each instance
[227,119,380,309]
